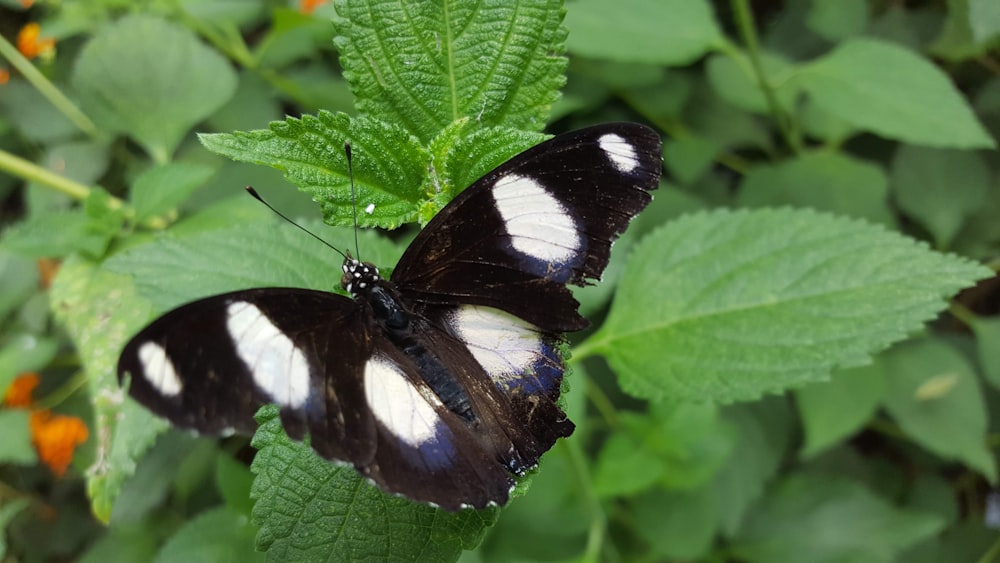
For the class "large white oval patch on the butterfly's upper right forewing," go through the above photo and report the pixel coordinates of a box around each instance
[493,174,580,263]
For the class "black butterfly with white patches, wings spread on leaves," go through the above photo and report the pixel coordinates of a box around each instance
[118,123,661,510]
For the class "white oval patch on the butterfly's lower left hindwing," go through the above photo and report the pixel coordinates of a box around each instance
[364,356,440,448]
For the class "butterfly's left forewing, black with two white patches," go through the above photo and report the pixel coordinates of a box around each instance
[118,288,375,462]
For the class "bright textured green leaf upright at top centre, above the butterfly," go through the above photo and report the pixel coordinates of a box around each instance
[334,0,566,143]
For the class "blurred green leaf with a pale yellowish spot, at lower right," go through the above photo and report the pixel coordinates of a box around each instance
[885,338,997,483]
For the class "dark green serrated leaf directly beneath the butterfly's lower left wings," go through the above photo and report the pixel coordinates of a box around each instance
[251,406,498,562]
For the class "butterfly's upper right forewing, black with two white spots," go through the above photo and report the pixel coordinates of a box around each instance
[392,123,662,333]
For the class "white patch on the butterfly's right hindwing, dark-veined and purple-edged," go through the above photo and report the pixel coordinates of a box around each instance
[448,305,554,388]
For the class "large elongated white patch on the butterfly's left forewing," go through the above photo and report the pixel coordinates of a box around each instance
[226,301,309,408]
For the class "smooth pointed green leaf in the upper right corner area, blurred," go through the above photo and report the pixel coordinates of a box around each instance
[797,39,996,148]
